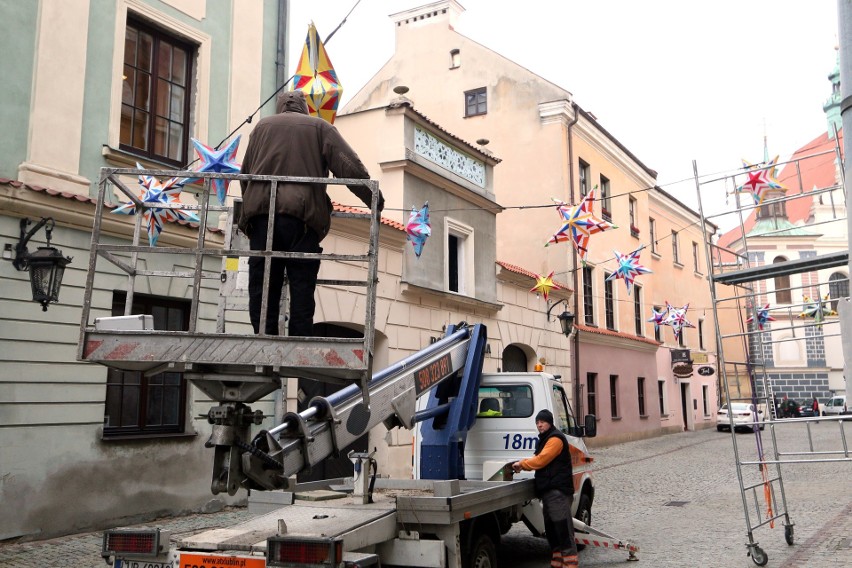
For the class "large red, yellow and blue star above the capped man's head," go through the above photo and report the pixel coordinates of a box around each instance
[291,22,343,124]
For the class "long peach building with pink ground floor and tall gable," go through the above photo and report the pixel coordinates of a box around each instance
[343,0,718,442]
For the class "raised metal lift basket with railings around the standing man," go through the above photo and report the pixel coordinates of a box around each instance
[78,168,380,406]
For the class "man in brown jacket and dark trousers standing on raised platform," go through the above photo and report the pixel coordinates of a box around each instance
[239,91,384,336]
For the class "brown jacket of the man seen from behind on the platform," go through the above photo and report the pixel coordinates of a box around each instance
[239,91,371,240]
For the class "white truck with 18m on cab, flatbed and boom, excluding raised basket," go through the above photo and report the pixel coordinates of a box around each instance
[98,325,620,568]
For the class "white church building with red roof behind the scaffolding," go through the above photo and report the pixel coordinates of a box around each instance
[719,54,849,403]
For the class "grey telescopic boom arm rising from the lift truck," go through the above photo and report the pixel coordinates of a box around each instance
[230,324,487,492]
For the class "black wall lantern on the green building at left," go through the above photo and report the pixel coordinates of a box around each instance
[12,217,71,312]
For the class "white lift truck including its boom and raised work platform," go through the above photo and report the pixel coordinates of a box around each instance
[78,168,638,568]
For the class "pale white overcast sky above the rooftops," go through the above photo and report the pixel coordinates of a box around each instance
[289,0,838,222]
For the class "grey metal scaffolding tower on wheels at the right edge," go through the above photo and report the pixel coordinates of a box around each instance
[693,141,852,566]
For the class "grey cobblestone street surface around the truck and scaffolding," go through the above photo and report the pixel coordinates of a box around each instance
[0,422,852,568]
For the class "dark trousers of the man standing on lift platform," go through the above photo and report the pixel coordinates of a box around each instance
[249,215,322,336]
